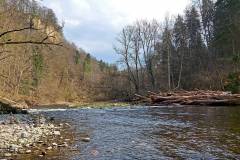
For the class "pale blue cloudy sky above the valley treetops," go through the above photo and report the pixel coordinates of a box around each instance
[39,0,190,63]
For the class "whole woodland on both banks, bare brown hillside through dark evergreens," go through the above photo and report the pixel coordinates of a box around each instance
[0,0,240,103]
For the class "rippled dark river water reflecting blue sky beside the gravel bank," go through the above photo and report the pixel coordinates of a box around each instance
[35,106,240,160]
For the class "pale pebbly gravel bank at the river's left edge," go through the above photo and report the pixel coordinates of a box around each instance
[0,114,72,159]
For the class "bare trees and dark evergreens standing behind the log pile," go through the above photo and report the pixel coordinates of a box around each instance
[115,0,240,95]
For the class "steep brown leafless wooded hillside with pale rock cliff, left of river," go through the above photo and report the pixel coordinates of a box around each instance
[0,0,122,103]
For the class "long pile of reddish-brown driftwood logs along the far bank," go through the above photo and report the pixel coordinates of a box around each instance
[135,90,240,106]
